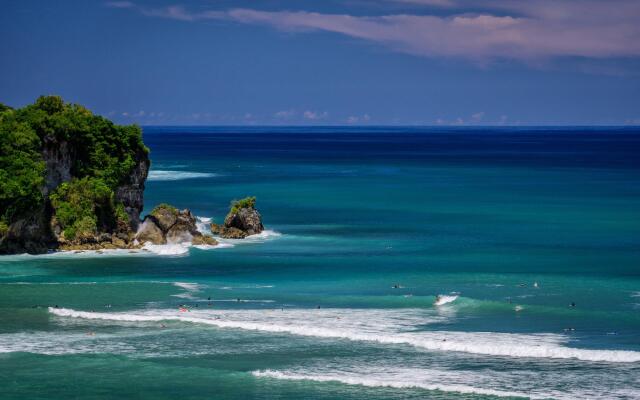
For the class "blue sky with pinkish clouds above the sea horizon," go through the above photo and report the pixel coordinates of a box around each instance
[0,0,640,126]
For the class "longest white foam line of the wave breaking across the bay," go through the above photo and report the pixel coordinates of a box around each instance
[49,308,640,362]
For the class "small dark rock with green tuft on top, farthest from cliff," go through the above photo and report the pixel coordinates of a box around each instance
[211,197,264,239]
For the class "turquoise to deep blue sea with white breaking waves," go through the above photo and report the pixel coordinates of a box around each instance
[0,128,640,399]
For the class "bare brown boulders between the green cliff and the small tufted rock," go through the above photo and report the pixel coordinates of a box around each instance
[135,204,218,245]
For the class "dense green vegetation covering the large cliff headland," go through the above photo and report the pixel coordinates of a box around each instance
[0,96,149,239]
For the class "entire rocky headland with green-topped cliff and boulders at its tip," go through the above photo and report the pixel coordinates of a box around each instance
[0,96,264,254]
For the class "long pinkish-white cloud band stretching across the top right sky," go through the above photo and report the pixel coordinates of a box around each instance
[117,0,640,62]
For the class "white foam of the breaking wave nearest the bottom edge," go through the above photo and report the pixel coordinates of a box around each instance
[252,369,542,398]
